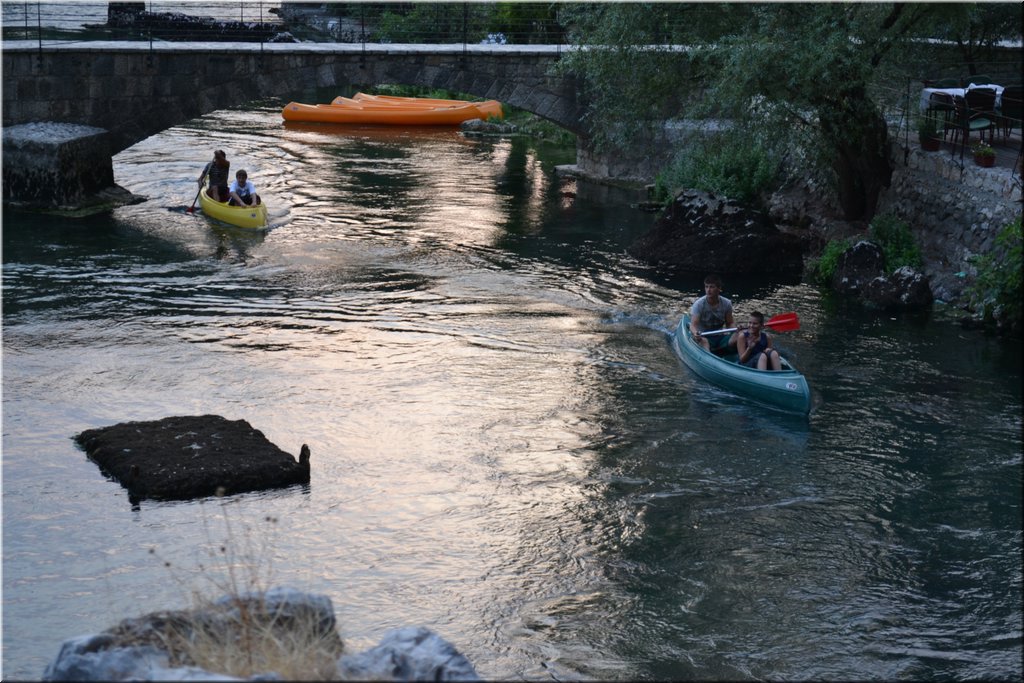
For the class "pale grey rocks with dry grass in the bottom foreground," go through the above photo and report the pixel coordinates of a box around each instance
[43,587,480,681]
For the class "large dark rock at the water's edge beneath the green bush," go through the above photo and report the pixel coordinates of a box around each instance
[628,190,804,282]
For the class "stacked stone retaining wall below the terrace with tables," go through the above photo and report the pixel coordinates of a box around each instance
[879,150,1021,301]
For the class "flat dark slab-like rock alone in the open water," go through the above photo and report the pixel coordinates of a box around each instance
[75,415,309,501]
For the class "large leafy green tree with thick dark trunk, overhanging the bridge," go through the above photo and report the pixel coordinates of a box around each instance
[563,3,948,220]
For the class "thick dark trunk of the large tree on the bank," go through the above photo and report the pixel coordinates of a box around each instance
[818,89,893,221]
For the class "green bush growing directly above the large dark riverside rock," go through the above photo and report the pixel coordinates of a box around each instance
[654,133,780,204]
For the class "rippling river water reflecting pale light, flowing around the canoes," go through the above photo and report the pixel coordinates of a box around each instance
[3,102,1022,680]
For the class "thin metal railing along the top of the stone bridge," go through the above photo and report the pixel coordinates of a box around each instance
[2,0,565,48]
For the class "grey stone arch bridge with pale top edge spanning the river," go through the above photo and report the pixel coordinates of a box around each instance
[3,41,586,204]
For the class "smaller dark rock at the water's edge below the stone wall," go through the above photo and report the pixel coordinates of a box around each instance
[831,240,934,310]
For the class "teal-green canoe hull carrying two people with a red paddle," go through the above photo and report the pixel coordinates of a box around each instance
[672,315,811,415]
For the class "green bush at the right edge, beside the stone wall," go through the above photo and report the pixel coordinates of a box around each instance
[966,217,1024,327]
